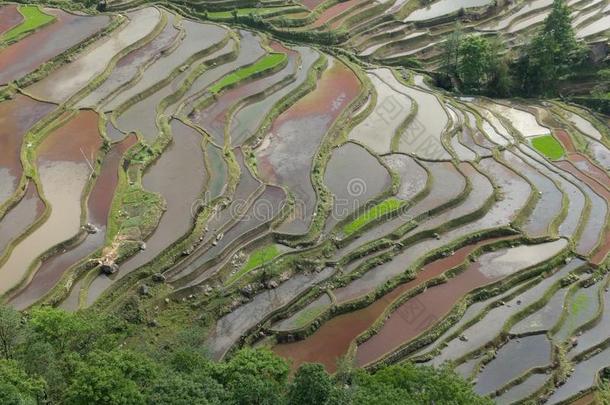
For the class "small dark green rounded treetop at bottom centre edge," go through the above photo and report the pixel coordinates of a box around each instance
[289,364,334,405]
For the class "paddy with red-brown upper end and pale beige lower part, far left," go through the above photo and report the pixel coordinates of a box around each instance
[0,111,102,293]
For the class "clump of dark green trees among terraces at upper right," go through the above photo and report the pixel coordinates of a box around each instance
[440,0,587,96]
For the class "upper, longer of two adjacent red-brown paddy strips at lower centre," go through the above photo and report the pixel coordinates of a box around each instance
[273,239,508,372]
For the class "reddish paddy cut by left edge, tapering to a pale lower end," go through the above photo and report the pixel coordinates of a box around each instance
[0,95,55,205]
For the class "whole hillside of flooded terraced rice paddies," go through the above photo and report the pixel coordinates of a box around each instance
[0,0,610,403]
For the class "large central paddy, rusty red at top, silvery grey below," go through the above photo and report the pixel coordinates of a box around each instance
[256,59,360,233]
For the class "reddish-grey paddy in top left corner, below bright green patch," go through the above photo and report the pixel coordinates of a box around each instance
[0,10,110,84]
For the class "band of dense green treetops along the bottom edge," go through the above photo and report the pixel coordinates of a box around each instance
[0,306,490,405]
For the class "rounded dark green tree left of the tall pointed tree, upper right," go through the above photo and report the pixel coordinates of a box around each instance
[457,35,494,92]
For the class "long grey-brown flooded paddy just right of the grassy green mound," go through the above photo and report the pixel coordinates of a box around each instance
[87,120,208,304]
